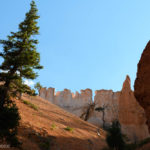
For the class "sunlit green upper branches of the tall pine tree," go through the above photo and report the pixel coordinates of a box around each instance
[0,1,42,98]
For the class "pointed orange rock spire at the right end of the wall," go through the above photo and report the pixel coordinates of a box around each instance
[118,76,149,141]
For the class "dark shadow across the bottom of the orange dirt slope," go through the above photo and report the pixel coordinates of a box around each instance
[18,126,105,150]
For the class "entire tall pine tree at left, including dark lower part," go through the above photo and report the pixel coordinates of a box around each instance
[0,1,42,146]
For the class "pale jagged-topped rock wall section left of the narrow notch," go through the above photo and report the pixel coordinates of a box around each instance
[39,88,92,119]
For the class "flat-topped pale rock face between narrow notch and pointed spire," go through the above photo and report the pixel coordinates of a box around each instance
[88,90,120,127]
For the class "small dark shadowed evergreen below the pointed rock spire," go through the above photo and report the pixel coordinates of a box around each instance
[106,121,125,150]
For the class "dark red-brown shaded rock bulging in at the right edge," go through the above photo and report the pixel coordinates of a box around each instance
[134,41,150,132]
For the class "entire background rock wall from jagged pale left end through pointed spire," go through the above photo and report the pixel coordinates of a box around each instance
[40,76,149,141]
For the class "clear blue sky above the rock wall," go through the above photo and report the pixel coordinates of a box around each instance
[0,0,150,94]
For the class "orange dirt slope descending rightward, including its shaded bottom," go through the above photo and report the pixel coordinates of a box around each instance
[1,95,106,150]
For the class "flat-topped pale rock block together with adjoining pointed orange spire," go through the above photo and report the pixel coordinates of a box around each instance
[87,76,149,142]
